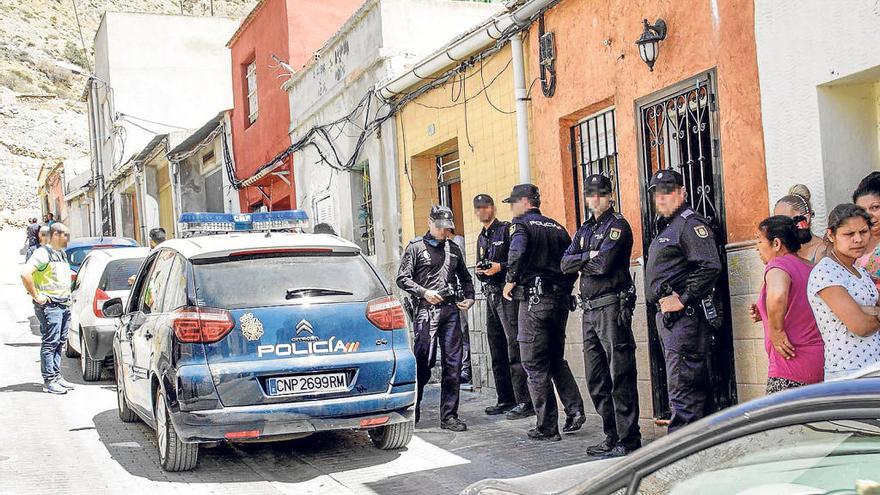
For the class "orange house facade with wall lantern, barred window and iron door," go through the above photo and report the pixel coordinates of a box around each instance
[527,0,769,432]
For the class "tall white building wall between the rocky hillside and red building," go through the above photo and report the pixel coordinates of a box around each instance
[92,12,238,234]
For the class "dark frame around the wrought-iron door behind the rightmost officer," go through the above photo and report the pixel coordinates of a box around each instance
[633,67,738,419]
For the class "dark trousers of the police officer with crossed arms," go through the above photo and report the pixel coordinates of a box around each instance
[582,303,642,449]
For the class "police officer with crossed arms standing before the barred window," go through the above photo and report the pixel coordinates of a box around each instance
[561,174,642,457]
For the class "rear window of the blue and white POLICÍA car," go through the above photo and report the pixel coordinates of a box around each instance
[193,253,386,309]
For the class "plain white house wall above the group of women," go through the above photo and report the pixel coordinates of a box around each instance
[755,0,880,232]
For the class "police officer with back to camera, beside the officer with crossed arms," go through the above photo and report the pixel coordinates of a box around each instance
[503,184,586,441]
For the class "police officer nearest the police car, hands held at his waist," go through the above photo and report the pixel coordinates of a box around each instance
[397,206,474,431]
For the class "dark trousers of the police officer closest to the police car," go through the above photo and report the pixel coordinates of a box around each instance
[413,303,462,421]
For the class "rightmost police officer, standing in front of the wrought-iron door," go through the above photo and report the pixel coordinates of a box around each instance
[645,170,721,432]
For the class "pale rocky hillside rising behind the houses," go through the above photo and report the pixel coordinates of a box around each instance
[0,0,257,228]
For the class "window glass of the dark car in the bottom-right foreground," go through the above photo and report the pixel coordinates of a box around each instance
[636,420,880,495]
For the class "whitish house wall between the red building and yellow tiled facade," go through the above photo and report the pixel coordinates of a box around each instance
[289,0,501,278]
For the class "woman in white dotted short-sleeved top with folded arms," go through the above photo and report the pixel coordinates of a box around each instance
[807,204,880,380]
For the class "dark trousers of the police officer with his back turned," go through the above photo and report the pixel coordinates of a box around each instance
[517,296,584,435]
